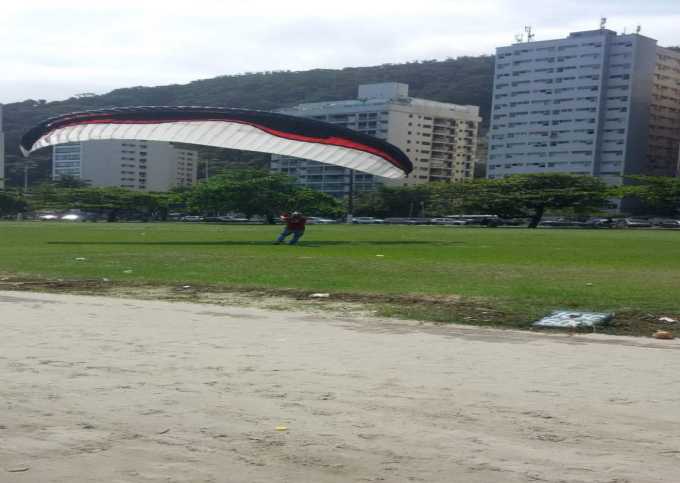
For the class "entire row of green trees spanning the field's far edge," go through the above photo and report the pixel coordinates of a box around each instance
[0,169,680,227]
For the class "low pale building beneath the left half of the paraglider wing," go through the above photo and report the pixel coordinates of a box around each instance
[52,140,198,191]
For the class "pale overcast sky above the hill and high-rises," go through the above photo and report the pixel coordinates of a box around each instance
[0,0,680,102]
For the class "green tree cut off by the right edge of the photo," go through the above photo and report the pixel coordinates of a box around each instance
[618,176,680,216]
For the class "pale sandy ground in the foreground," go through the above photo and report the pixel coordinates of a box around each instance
[0,292,680,483]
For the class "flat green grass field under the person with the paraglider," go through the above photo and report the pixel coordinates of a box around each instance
[0,222,680,332]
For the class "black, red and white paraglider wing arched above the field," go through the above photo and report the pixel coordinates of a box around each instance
[21,107,413,178]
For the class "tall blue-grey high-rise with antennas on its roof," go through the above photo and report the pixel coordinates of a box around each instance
[487,29,677,184]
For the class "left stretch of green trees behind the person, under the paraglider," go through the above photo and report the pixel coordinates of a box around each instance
[0,170,345,222]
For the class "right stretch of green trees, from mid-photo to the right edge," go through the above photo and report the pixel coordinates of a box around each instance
[355,173,680,227]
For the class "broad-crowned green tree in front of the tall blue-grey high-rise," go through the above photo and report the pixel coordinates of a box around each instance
[461,173,612,228]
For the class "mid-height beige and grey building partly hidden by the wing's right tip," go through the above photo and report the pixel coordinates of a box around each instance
[271,82,481,197]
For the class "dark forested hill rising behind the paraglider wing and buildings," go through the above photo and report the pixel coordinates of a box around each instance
[4,56,493,185]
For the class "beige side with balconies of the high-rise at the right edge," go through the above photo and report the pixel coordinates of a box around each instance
[645,47,680,176]
